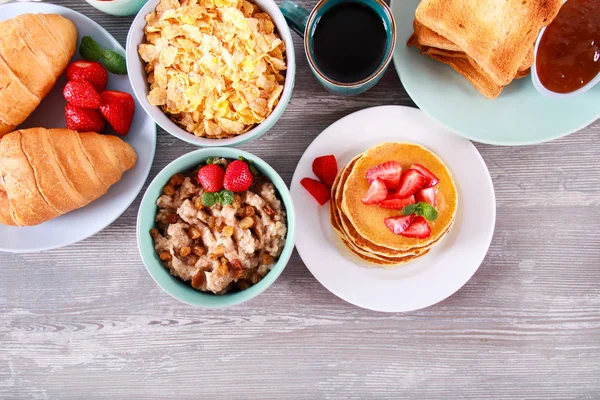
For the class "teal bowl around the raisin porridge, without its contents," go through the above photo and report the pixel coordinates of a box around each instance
[137,147,296,308]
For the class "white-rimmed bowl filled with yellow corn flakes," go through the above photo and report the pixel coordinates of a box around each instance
[126,0,296,147]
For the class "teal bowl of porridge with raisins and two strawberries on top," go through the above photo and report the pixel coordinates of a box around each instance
[137,148,295,308]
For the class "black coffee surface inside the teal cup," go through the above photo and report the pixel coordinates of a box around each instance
[313,1,387,83]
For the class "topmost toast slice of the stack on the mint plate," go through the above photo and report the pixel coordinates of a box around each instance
[415,0,562,86]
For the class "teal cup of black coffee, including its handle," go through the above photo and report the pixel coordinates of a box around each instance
[280,0,396,95]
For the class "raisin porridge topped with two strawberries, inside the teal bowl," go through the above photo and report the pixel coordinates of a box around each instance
[150,158,287,294]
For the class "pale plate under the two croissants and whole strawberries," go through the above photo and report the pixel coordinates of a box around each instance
[0,3,156,253]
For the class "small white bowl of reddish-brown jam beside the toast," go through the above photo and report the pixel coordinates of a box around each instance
[531,0,600,97]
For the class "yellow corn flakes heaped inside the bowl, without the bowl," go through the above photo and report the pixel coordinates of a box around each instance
[138,0,286,139]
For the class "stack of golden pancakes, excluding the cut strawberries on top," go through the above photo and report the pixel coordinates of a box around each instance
[330,142,457,268]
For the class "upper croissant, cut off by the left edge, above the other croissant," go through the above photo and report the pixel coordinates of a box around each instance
[0,14,77,138]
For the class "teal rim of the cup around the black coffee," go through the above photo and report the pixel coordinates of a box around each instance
[304,0,396,89]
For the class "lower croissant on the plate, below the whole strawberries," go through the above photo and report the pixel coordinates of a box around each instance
[0,128,137,226]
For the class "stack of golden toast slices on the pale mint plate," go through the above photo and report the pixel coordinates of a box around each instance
[407,0,562,99]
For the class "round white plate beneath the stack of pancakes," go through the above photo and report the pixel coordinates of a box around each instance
[291,106,496,312]
